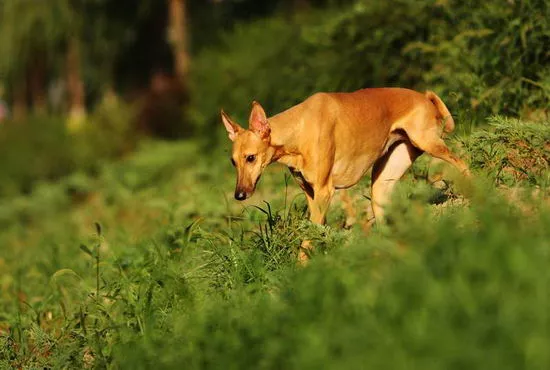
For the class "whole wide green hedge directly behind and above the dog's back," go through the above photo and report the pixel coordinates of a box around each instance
[190,0,550,137]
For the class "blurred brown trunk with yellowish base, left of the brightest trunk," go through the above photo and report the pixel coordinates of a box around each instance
[66,38,86,127]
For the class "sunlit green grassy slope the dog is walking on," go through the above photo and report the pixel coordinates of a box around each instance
[0,118,550,369]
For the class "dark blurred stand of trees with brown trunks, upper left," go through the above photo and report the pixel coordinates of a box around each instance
[0,0,326,121]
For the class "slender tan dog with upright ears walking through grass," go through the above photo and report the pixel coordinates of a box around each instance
[221,88,469,259]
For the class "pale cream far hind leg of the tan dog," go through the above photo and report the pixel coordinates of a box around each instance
[372,141,422,222]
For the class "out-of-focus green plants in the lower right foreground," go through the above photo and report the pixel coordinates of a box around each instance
[115,184,550,369]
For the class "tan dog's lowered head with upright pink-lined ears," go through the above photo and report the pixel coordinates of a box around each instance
[221,102,274,200]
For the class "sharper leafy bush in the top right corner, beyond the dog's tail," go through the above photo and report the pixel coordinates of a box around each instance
[404,0,550,116]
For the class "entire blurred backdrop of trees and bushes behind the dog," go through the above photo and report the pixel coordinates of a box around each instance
[0,0,550,195]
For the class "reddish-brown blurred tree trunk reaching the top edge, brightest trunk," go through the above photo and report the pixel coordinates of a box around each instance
[168,0,190,87]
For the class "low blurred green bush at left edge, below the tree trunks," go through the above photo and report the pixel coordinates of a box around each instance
[0,102,139,197]
